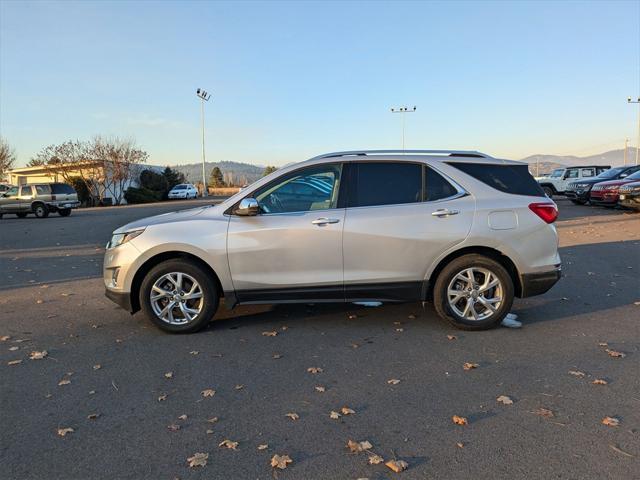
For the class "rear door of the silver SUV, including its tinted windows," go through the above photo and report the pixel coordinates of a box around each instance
[343,162,475,301]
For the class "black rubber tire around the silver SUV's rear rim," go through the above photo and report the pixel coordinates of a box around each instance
[433,254,514,330]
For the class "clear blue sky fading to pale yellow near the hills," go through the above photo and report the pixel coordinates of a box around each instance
[0,0,640,165]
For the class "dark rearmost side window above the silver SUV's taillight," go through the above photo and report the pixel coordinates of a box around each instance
[449,162,544,197]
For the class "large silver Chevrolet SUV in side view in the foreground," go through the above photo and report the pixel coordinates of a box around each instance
[104,150,560,333]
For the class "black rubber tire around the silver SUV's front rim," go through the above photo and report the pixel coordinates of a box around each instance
[139,259,220,333]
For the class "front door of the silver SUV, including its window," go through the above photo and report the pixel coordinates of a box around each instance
[227,163,344,302]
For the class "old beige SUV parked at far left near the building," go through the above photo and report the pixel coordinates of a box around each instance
[0,183,80,218]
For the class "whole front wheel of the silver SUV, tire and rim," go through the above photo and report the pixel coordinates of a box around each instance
[140,260,220,333]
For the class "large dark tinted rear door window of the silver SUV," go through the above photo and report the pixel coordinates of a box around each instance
[348,162,422,207]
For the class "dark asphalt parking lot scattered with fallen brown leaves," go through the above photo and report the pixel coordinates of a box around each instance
[0,200,640,479]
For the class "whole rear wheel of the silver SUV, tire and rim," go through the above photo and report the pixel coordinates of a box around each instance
[433,254,514,330]
